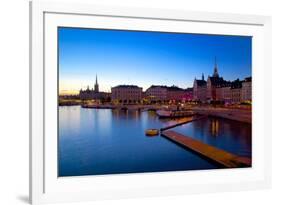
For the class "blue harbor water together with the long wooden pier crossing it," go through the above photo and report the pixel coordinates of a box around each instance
[59,105,251,176]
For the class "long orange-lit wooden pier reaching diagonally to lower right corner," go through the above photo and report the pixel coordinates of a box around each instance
[161,130,252,168]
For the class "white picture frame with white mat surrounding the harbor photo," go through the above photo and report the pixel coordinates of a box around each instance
[30,1,271,204]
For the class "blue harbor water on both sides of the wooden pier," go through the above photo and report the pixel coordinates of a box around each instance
[58,106,251,176]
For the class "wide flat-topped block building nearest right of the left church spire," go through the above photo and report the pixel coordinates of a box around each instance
[111,85,142,104]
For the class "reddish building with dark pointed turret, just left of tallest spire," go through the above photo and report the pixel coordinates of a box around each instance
[193,74,207,102]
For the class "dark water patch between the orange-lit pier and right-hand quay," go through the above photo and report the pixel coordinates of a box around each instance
[173,117,252,157]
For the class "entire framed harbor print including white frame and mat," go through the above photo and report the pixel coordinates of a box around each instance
[30,2,271,204]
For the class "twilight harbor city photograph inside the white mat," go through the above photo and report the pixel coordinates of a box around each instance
[57,26,252,177]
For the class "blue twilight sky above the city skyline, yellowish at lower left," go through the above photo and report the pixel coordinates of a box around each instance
[58,28,252,93]
